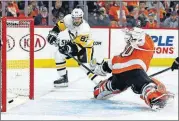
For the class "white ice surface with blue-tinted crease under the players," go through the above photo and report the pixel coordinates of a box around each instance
[1,67,178,120]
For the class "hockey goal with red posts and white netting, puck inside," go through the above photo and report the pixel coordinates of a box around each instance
[0,17,34,112]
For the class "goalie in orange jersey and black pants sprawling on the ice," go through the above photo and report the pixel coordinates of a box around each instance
[91,27,176,110]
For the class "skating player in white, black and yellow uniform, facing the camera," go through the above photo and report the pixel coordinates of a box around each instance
[47,8,94,87]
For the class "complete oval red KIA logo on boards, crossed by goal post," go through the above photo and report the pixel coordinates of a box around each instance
[19,34,46,52]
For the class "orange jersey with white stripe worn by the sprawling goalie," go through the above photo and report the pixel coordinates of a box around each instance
[112,34,154,74]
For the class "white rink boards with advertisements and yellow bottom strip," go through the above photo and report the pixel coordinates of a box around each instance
[7,27,178,68]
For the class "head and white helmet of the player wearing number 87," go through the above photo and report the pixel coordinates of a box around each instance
[71,8,84,26]
